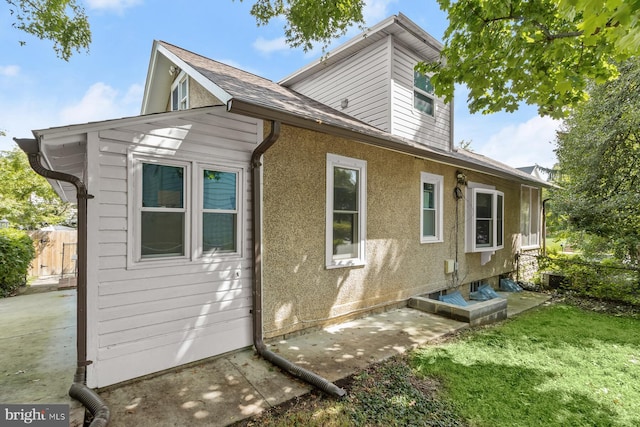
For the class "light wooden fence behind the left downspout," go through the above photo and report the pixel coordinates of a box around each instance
[29,230,78,278]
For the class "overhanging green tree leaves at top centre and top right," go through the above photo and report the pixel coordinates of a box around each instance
[241,0,640,118]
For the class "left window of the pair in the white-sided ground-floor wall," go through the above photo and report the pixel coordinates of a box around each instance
[139,163,188,259]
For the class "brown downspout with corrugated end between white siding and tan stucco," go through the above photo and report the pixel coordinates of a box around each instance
[251,121,346,397]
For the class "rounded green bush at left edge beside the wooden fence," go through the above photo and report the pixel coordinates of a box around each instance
[0,228,35,297]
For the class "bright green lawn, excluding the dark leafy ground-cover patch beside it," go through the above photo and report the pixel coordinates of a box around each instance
[412,305,640,427]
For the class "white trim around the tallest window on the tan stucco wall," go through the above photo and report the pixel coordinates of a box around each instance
[325,153,367,269]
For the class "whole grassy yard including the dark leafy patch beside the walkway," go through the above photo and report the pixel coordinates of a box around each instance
[240,304,640,427]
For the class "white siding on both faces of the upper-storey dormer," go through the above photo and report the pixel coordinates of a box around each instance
[282,38,452,150]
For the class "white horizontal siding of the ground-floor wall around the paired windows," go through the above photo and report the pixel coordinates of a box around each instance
[72,107,262,387]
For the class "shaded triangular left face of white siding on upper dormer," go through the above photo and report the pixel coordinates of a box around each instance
[291,39,391,132]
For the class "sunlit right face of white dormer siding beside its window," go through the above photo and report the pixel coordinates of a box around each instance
[390,44,452,150]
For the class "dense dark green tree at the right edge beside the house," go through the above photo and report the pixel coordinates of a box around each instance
[552,58,640,264]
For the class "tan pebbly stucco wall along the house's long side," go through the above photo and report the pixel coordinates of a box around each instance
[263,126,520,337]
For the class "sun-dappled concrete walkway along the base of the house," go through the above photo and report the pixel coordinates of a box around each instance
[100,292,548,427]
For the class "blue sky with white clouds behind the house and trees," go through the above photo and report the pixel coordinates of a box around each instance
[0,0,559,167]
